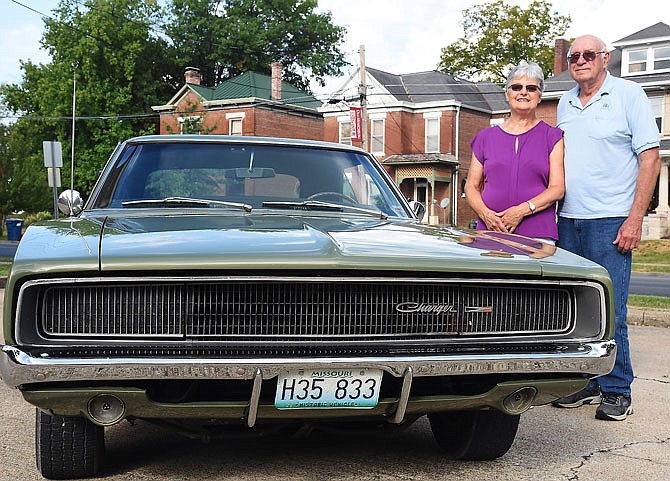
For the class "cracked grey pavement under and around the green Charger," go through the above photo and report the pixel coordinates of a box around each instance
[0,298,670,481]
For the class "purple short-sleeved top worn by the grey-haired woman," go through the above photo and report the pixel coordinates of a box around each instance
[470,121,563,240]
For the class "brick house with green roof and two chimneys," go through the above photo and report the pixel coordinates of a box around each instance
[152,63,323,140]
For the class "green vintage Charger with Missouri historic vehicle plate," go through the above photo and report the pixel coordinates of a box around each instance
[0,135,616,479]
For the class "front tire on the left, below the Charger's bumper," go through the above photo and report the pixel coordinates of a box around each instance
[35,409,105,479]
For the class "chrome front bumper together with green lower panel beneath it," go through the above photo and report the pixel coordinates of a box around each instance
[0,341,616,427]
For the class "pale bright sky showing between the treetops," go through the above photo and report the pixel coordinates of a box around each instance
[0,0,670,97]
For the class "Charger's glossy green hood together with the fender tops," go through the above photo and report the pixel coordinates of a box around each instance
[15,213,597,277]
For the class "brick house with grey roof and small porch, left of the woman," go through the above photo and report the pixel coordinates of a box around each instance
[319,68,509,225]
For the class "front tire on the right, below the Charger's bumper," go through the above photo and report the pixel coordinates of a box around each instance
[428,409,520,460]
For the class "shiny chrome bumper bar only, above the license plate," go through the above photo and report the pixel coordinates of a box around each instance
[0,341,616,387]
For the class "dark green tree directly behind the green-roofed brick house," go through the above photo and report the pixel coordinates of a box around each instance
[167,0,347,89]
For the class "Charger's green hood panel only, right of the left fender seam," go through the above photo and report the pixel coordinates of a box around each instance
[94,214,600,275]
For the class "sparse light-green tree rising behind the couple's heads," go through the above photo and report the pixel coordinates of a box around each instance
[438,0,571,84]
